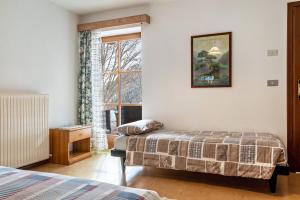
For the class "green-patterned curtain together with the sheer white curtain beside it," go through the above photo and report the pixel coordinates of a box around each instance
[78,31,107,151]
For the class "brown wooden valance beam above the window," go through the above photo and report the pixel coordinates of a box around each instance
[77,14,150,32]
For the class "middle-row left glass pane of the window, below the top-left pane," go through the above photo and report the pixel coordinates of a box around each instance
[103,73,119,103]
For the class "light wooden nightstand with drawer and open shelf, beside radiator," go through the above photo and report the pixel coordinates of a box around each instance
[50,126,92,165]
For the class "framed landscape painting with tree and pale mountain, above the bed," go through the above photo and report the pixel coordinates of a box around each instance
[191,32,232,88]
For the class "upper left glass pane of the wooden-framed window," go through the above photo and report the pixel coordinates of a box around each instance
[101,42,118,73]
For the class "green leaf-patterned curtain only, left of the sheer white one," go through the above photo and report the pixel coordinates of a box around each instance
[78,31,92,125]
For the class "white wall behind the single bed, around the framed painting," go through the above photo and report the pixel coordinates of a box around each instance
[80,0,286,142]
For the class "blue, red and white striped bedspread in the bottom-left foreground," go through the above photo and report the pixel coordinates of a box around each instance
[0,167,160,200]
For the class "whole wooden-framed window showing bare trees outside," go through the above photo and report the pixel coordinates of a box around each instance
[101,33,142,125]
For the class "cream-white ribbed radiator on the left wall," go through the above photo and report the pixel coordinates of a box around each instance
[0,94,49,167]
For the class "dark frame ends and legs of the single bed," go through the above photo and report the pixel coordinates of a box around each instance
[111,149,290,193]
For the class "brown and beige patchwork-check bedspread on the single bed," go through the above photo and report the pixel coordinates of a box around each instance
[125,130,287,179]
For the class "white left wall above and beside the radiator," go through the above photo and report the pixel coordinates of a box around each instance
[0,0,79,127]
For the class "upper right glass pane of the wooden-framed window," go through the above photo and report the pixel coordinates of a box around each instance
[120,39,142,71]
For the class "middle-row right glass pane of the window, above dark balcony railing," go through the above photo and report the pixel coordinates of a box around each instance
[121,72,142,104]
